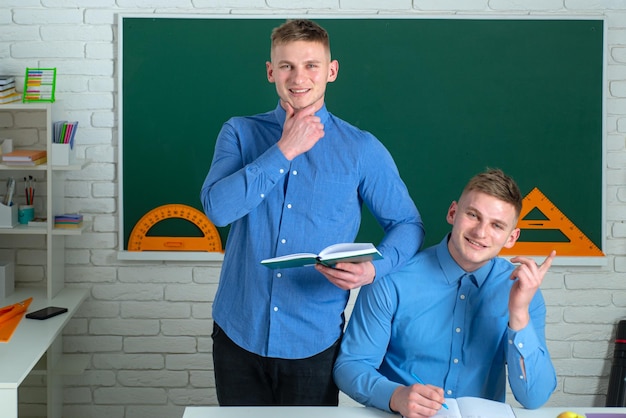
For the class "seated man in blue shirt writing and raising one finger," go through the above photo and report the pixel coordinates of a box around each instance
[334,170,556,418]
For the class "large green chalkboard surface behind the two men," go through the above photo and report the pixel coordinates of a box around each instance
[120,16,604,255]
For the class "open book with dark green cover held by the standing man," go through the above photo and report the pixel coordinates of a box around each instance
[261,243,383,269]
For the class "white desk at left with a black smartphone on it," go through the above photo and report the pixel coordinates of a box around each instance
[0,288,87,418]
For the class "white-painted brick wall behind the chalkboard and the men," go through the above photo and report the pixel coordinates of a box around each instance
[0,0,626,418]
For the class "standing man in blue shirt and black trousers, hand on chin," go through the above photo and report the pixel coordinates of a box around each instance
[201,20,424,405]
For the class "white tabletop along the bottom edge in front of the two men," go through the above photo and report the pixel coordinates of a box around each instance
[183,406,626,418]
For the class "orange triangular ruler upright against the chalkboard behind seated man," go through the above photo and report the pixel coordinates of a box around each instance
[500,187,604,257]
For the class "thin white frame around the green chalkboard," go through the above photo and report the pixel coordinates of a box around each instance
[118,14,607,265]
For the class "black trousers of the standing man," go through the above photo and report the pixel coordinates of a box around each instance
[211,323,340,406]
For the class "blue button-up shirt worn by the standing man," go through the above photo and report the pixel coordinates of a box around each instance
[201,105,424,358]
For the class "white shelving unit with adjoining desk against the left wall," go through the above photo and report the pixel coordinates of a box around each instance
[0,103,90,418]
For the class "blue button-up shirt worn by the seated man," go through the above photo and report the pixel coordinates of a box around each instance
[334,237,556,410]
